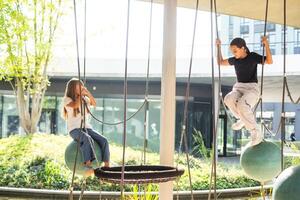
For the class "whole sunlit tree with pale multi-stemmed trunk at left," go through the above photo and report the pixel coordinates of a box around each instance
[0,0,62,134]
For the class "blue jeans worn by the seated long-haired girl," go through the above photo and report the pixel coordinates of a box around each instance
[70,128,110,162]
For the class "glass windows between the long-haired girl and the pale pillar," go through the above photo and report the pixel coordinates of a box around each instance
[98,98,160,152]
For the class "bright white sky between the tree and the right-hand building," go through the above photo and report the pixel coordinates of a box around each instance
[55,0,214,59]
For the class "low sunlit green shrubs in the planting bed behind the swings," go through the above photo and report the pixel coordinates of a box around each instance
[0,134,259,191]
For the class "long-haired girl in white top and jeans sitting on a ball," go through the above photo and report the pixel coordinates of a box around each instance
[62,78,110,176]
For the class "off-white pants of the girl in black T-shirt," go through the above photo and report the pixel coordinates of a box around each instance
[224,83,259,130]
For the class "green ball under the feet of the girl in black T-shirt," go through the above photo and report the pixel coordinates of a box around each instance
[240,141,281,183]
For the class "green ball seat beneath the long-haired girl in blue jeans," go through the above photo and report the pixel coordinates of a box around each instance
[65,140,102,175]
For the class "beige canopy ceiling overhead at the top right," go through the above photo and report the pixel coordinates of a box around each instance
[147,0,300,28]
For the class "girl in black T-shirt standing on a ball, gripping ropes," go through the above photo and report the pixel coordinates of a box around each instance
[216,37,273,145]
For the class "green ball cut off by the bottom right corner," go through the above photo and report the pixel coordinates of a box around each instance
[272,166,300,200]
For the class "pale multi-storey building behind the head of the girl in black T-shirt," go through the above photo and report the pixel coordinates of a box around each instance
[219,15,300,56]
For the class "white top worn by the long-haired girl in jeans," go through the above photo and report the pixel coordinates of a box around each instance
[63,96,92,132]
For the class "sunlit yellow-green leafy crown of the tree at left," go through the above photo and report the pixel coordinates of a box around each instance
[0,0,62,85]
